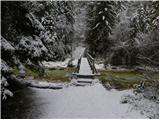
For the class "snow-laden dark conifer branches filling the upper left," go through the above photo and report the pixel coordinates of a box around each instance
[1,1,74,99]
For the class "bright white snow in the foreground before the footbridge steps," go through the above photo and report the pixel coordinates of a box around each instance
[24,83,146,119]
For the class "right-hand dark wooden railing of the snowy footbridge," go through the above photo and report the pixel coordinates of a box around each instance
[86,53,97,74]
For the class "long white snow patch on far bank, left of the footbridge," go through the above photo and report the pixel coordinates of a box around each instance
[42,58,70,68]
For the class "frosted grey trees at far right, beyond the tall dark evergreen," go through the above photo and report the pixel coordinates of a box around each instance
[107,1,159,65]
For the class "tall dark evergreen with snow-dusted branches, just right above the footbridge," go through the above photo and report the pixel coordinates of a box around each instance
[86,1,116,55]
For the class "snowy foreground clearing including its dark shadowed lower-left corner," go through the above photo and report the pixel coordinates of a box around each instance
[2,81,145,119]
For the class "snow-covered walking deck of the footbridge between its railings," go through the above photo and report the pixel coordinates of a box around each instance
[79,57,92,75]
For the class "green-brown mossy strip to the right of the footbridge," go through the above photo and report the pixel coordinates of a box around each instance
[99,70,159,89]
